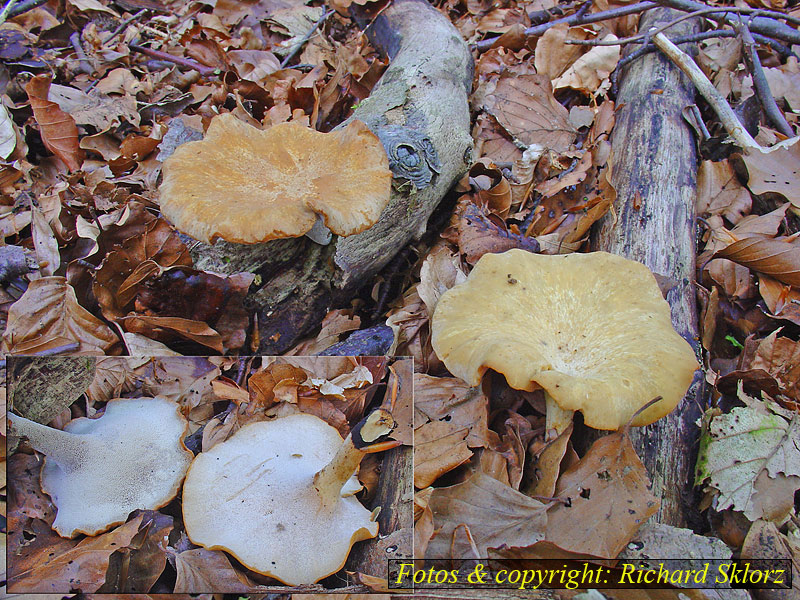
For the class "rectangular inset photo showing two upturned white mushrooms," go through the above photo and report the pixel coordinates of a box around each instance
[5,356,414,599]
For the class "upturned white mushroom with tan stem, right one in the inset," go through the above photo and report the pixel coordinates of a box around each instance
[183,409,393,585]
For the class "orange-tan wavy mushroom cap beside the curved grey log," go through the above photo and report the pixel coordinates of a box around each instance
[160,113,392,244]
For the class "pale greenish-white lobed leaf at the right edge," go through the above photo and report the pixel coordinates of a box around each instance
[696,398,800,521]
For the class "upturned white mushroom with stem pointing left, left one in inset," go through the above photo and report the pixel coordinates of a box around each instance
[8,397,193,537]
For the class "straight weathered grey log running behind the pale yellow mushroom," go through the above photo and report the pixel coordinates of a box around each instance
[593,9,702,527]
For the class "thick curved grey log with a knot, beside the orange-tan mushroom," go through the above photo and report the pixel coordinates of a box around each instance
[192,0,473,354]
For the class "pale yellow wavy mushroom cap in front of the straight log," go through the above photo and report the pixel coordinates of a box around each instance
[432,250,698,429]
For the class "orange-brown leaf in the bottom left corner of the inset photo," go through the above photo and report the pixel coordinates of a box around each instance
[8,514,144,594]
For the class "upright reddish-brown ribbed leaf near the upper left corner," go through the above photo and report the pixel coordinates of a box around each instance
[25,75,83,171]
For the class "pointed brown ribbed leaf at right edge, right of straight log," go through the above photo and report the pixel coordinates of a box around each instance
[714,237,800,286]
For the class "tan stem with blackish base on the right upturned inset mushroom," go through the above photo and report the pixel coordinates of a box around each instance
[314,408,394,506]
